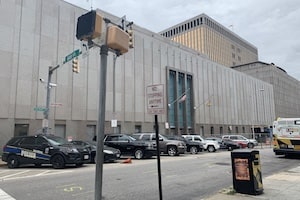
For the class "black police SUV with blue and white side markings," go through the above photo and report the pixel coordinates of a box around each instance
[2,134,90,169]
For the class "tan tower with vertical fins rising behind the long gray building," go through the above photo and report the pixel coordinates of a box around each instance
[160,14,258,67]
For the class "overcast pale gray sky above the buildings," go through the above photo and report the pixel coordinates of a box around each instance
[65,0,300,81]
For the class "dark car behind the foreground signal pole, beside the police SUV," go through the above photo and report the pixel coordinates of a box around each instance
[71,140,121,163]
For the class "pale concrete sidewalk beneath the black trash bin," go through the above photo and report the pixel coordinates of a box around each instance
[202,166,300,200]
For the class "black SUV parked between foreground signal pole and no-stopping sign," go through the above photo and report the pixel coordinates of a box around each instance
[104,134,156,159]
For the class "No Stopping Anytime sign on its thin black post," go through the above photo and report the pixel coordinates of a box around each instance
[147,85,165,200]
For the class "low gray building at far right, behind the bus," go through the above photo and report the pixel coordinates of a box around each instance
[233,62,300,118]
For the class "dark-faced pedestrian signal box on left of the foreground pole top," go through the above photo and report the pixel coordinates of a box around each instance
[76,10,103,41]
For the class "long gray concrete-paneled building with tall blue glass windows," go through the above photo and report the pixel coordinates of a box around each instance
[0,0,275,150]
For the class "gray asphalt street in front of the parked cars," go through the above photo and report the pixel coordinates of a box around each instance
[0,148,299,200]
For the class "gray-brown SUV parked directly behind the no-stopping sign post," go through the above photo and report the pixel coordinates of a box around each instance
[132,133,186,156]
